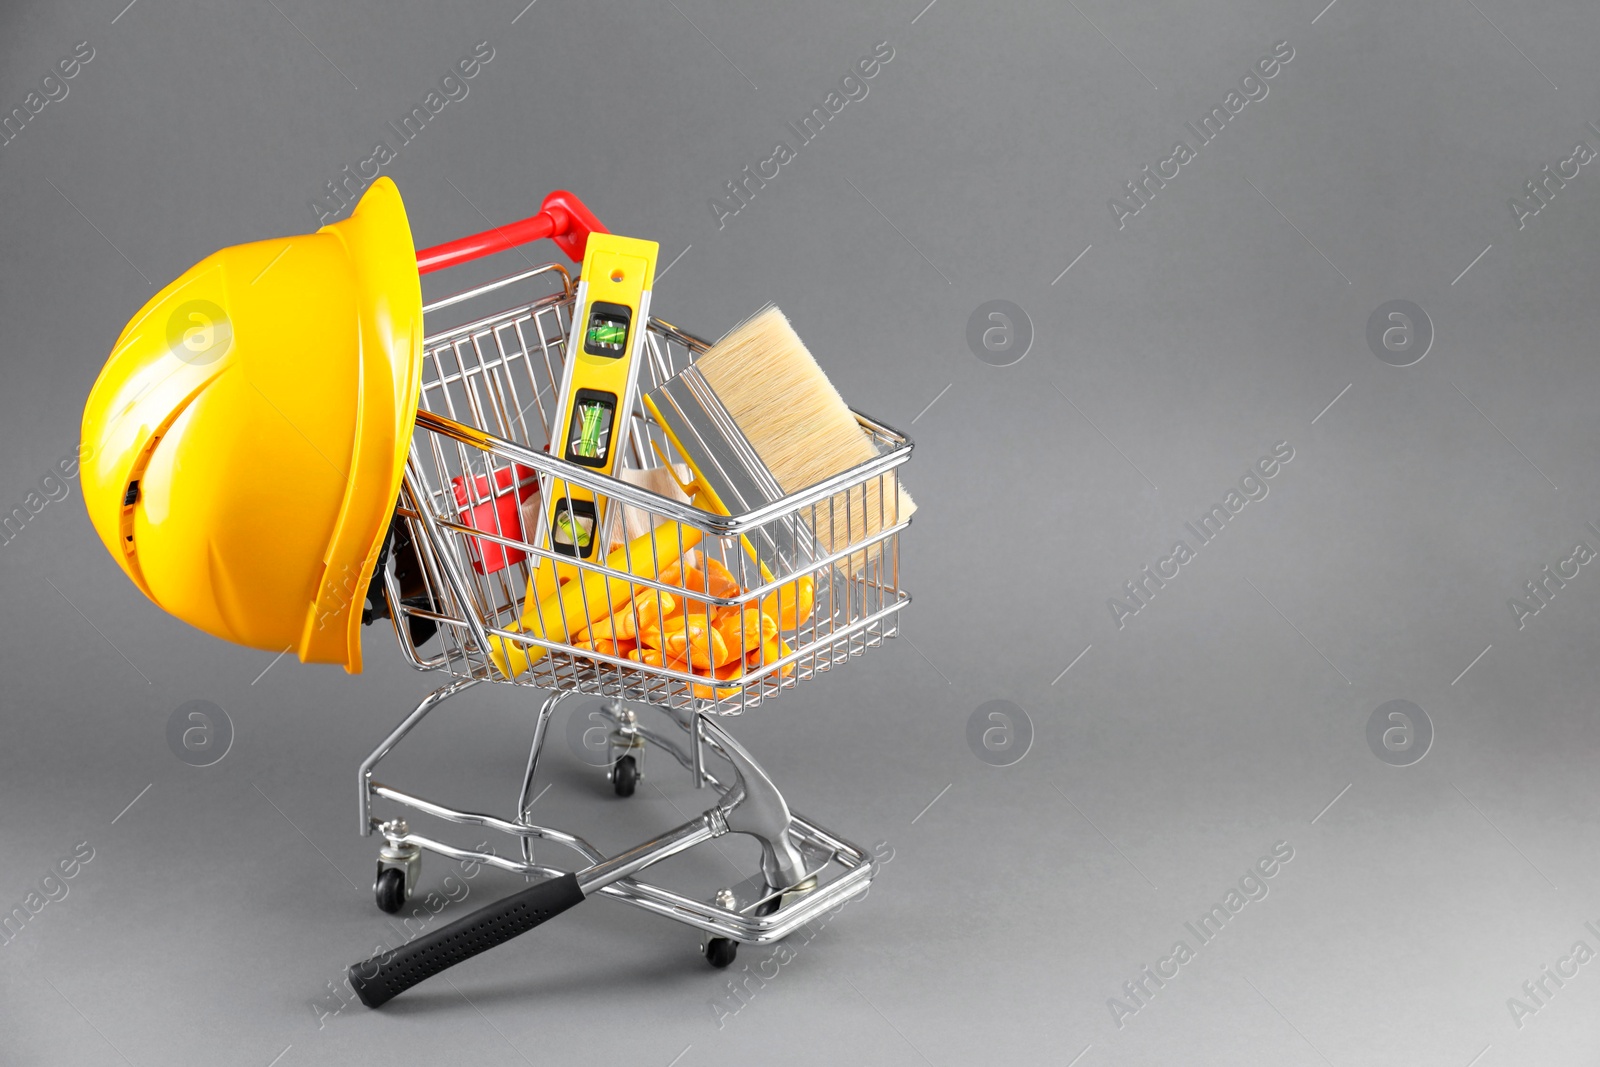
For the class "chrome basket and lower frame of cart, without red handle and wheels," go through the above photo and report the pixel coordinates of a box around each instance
[358,264,912,944]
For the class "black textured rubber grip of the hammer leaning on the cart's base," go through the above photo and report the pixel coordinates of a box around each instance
[350,875,584,1008]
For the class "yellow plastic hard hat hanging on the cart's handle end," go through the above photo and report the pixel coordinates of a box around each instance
[82,178,422,673]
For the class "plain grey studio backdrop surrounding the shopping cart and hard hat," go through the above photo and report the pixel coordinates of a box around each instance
[0,0,1600,1067]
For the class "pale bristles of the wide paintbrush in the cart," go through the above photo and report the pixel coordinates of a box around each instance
[694,307,917,571]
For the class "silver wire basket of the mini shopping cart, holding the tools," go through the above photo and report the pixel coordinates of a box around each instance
[386,264,910,713]
